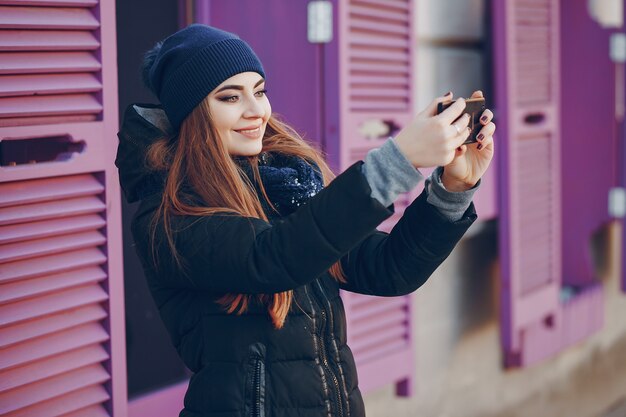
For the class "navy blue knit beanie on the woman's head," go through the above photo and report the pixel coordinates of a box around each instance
[142,24,265,130]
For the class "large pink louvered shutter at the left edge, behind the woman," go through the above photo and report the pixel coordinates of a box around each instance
[0,0,126,416]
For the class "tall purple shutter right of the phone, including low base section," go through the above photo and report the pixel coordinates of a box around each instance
[493,0,602,366]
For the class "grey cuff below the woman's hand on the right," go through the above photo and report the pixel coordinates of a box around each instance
[424,167,482,221]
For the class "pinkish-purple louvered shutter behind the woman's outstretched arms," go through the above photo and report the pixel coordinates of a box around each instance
[331,0,416,395]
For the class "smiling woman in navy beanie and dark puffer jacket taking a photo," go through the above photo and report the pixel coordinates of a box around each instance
[116,25,495,417]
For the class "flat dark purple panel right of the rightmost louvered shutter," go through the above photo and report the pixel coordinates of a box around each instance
[561,2,618,286]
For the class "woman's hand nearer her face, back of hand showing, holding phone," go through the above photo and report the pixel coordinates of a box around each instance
[395,93,470,168]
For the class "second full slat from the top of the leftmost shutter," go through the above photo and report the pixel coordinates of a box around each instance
[0,30,100,52]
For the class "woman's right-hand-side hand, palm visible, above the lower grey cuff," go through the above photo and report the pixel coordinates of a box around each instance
[441,90,496,191]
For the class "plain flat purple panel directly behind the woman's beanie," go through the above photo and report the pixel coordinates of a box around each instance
[201,0,323,150]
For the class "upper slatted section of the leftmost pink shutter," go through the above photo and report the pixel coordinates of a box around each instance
[0,0,102,126]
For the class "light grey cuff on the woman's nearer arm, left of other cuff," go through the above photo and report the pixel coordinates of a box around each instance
[361,138,424,207]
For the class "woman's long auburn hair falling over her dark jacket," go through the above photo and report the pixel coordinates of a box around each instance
[147,98,346,329]
